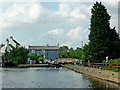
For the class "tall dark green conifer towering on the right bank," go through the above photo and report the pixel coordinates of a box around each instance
[85,2,120,62]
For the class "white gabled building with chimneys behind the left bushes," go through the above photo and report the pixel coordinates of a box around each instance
[0,36,20,60]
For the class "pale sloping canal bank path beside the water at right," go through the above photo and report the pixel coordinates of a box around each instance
[64,65,120,84]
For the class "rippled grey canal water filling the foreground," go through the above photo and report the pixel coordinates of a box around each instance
[2,67,117,88]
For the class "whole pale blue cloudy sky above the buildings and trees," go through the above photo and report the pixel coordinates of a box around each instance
[0,0,118,49]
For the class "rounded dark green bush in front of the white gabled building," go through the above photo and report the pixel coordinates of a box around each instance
[2,47,28,66]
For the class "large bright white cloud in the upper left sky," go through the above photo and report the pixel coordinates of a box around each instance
[0,3,42,28]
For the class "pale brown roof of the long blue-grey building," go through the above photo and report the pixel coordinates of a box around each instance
[29,46,59,50]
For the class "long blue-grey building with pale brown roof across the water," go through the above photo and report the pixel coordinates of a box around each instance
[29,45,59,60]
